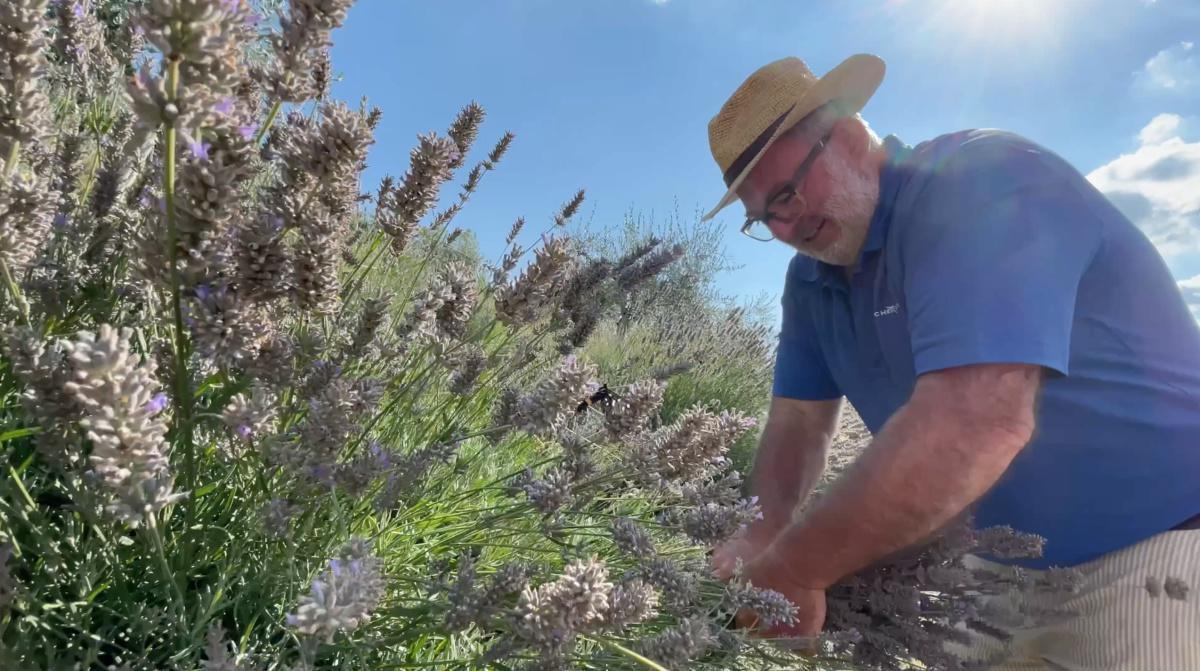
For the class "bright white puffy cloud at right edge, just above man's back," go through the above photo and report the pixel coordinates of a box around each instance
[1087,114,1200,257]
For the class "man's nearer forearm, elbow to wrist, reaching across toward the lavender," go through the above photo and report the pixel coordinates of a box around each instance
[767,396,1027,588]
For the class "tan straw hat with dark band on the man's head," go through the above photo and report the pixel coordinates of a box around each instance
[701,54,884,221]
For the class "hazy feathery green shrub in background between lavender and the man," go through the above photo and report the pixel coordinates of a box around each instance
[580,208,774,473]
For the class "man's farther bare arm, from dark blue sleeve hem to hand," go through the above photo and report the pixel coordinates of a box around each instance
[750,396,842,538]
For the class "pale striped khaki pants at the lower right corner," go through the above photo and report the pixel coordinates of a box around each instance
[948,529,1200,671]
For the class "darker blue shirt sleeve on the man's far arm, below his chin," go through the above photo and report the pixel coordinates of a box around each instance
[772,256,841,401]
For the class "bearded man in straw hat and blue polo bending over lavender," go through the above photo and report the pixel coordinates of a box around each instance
[704,55,1200,671]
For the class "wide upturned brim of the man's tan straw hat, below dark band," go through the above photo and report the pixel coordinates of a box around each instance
[700,54,886,222]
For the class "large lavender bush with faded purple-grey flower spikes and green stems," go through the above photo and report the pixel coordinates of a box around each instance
[0,0,1084,671]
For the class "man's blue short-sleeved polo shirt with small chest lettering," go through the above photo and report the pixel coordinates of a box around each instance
[774,130,1200,568]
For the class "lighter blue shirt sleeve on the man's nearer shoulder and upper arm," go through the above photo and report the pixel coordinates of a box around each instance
[899,136,1103,376]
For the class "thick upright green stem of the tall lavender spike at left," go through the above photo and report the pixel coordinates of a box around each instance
[162,59,196,490]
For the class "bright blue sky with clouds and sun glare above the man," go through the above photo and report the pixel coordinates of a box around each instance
[334,0,1200,313]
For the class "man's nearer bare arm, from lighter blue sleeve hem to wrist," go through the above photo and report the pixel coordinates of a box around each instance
[754,364,1040,589]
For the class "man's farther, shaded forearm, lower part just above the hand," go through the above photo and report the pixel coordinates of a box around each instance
[750,424,828,531]
